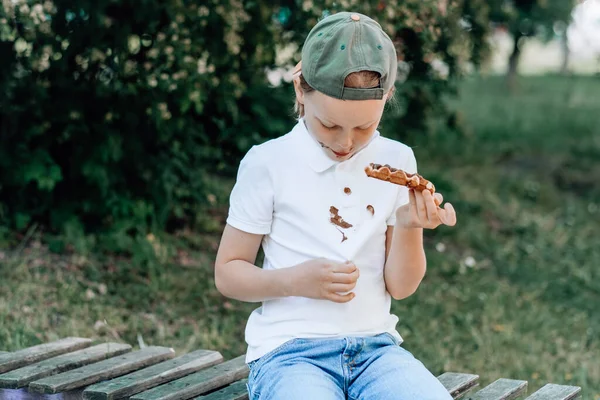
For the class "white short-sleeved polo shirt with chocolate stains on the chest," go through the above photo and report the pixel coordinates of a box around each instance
[227,119,417,362]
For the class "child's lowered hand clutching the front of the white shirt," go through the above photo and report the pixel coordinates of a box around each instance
[289,258,359,303]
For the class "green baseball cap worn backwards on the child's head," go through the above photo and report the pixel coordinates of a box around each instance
[297,12,398,100]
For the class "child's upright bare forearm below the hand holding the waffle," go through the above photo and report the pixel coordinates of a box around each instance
[384,224,427,300]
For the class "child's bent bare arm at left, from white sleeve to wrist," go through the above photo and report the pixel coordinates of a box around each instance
[215,225,289,302]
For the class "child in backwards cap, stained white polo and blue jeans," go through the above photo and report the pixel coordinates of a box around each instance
[215,12,456,400]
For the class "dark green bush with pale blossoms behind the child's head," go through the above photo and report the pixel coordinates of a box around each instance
[0,0,568,251]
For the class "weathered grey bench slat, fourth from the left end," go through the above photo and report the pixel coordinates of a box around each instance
[83,350,223,400]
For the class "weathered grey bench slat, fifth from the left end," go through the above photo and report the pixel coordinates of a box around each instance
[130,355,250,400]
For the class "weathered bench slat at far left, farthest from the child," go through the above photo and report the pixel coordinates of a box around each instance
[0,337,92,374]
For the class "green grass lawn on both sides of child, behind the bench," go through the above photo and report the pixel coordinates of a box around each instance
[0,76,600,399]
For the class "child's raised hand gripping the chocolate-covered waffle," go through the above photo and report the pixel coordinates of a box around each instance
[396,189,456,229]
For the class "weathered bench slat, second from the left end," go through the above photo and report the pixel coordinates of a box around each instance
[0,343,131,389]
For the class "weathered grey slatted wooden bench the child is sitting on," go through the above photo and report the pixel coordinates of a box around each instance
[0,337,581,400]
